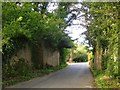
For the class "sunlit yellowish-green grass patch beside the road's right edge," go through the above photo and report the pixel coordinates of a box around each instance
[91,68,120,88]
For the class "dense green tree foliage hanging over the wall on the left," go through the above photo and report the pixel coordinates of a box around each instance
[2,2,71,61]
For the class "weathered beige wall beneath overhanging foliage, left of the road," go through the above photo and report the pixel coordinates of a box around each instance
[10,43,59,68]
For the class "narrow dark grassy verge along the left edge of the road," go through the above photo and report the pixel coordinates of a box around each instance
[2,64,67,88]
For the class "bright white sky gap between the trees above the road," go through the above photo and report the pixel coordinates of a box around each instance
[66,3,86,43]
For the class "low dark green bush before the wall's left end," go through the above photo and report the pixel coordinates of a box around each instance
[2,58,31,80]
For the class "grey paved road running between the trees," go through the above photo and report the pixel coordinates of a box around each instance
[7,63,93,88]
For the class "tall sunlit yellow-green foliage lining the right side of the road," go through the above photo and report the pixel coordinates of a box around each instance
[83,2,120,78]
